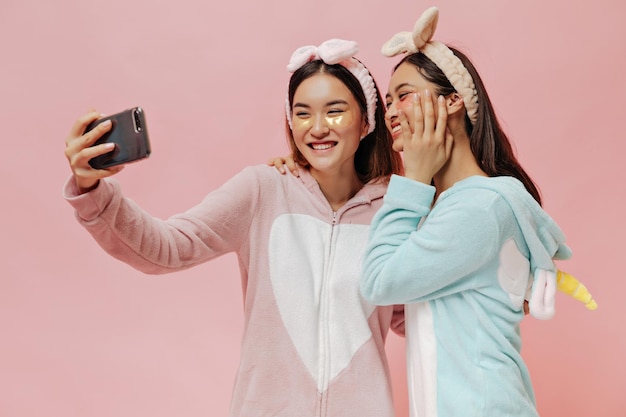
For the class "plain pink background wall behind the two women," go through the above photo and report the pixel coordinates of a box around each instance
[0,0,626,417]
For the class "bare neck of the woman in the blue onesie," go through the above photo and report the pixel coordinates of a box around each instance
[433,122,488,199]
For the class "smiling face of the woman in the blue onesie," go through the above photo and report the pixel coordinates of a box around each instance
[385,62,438,152]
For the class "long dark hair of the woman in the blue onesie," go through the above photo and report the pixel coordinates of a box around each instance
[394,46,541,204]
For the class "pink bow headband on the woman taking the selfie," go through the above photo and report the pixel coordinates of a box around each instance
[285,39,378,139]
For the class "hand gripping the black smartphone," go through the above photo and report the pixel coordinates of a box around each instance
[65,109,124,193]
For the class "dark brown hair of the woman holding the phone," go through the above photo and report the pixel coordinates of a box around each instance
[285,60,402,183]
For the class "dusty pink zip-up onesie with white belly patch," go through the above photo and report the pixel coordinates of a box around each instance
[64,166,403,417]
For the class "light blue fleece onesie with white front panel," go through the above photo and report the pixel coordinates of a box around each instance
[362,176,571,417]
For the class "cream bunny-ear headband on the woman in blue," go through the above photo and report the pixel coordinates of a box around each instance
[382,7,478,125]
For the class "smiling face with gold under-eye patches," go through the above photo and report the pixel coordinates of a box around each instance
[291,73,367,175]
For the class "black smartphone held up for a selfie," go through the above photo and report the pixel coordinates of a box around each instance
[85,107,151,169]
